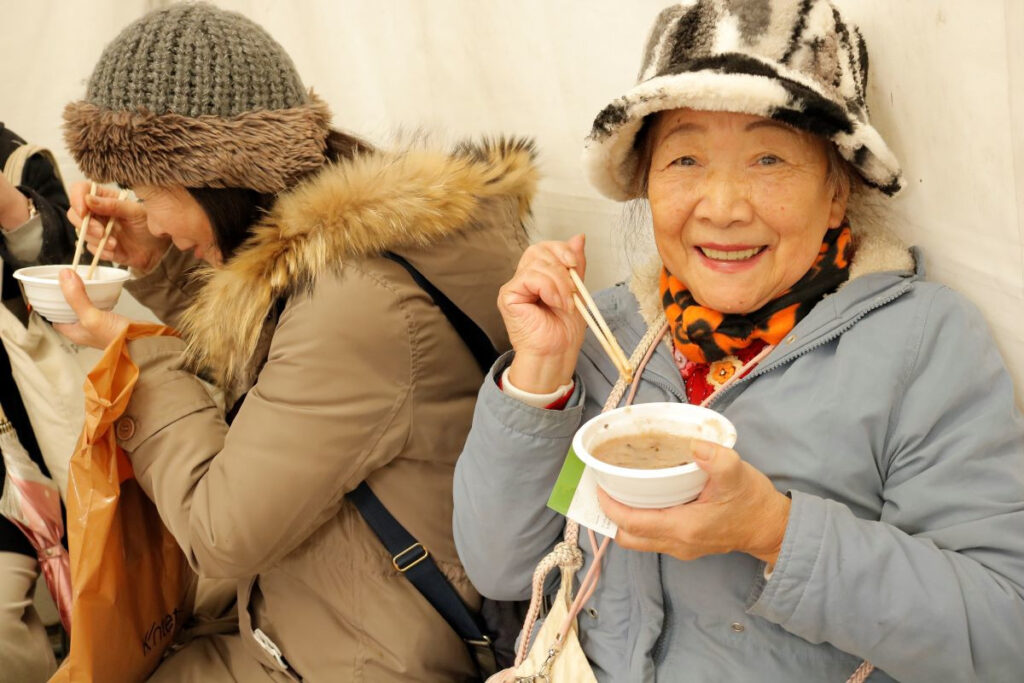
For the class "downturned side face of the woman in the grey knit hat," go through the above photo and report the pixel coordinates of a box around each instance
[133,185,222,267]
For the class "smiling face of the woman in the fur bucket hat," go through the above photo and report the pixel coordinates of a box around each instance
[647,110,848,313]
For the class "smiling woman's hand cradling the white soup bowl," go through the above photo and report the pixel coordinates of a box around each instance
[598,441,791,565]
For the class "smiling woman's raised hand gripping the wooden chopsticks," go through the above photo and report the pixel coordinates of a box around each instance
[498,234,587,393]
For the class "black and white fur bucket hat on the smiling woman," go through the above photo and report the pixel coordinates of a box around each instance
[584,0,902,200]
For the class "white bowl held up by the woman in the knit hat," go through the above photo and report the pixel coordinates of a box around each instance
[14,265,130,323]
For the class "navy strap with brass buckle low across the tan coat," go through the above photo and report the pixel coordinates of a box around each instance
[345,481,497,678]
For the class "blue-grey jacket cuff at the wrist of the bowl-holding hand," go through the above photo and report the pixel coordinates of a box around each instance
[746,490,829,627]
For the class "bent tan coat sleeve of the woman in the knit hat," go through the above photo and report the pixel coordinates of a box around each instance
[117,267,415,578]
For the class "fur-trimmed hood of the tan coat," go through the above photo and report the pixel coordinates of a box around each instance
[181,139,539,386]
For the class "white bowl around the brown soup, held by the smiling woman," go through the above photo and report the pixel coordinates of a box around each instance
[572,403,736,508]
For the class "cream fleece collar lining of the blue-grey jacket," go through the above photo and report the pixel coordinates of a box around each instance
[630,200,914,327]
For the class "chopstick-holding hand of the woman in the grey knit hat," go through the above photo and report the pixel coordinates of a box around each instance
[68,182,170,272]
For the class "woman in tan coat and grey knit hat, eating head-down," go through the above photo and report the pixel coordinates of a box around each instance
[54,5,536,682]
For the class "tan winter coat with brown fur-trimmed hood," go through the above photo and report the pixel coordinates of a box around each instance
[117,142,537,683]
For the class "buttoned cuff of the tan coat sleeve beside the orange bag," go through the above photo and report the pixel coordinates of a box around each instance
[116,337,216,454]
